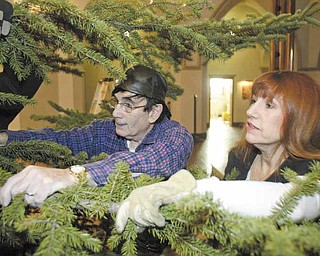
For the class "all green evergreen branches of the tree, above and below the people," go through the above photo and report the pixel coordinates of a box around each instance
[0,0,320,256]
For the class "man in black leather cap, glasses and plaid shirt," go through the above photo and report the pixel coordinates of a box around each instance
[0,65,193,206]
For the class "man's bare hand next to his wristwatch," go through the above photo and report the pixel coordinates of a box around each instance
[0,165,78,207]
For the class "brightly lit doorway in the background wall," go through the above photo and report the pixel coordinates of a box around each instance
[209,77,233,125]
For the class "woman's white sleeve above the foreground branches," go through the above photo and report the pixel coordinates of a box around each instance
[193,177,320,222]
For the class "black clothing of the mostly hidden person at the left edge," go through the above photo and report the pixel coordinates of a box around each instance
[0,64,43,129]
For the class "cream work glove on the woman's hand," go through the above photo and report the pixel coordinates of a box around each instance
[116,170,196,233]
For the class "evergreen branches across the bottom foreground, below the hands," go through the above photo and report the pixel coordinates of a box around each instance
[0,162,320,256]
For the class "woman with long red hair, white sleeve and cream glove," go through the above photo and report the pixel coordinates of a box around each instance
[116,71,320,232]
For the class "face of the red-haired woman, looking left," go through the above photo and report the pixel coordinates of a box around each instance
[246,96,283,149]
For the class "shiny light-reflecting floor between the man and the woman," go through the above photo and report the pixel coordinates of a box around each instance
[189,118,242,176]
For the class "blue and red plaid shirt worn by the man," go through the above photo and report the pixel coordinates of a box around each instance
[7,119,193,185]
